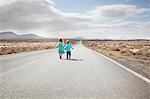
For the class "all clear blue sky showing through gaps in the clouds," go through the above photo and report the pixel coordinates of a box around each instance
[53,0,150,23]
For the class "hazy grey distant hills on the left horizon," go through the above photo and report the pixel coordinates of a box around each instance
[0,32,47,40]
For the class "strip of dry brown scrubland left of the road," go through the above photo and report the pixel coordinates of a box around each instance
[0,41,57,55]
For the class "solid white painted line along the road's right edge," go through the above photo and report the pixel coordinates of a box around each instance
[86,47,150,84]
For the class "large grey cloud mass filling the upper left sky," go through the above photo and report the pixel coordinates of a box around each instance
[0,0,89,31]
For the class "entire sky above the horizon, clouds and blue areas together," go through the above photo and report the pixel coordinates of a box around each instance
[0,0,150,39]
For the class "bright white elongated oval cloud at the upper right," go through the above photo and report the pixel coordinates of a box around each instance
[87,5,150,19]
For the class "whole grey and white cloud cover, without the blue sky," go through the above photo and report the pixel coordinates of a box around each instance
[0,0,150,38]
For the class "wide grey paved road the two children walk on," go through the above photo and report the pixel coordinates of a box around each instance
[0,44,150,99]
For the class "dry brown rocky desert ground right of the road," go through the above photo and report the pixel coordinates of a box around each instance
[83,40,150,79]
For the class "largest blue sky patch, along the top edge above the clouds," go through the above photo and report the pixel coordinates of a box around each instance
[53,0,150,13]
